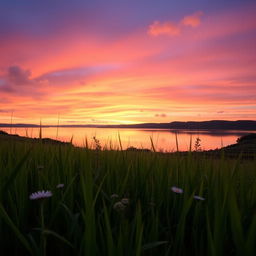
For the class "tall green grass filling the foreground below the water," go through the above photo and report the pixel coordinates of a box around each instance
[0,137,256,256]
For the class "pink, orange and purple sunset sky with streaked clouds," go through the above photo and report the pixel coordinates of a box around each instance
[0,0,256,124]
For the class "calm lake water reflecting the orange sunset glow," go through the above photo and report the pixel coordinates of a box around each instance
[1,127,256,151]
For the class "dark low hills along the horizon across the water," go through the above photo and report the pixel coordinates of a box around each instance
[0,120,256,131]
